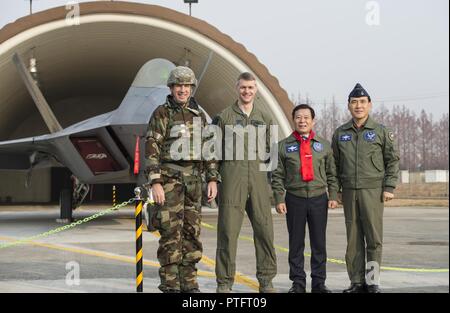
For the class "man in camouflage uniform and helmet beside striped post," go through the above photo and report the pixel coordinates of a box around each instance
[146,66,220,293]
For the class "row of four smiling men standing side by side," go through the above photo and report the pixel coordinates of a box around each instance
[146,66,399,293]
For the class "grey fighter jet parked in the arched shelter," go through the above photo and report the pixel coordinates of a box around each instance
[0,54,200,220]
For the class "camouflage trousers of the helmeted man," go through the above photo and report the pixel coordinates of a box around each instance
[152,167,203,292]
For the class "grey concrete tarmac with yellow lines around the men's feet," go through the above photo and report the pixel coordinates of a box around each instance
[0,206,449,293]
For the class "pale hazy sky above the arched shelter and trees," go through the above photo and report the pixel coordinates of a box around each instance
[0,0,449,117]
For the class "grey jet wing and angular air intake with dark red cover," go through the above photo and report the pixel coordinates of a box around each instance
[0,112,134,183]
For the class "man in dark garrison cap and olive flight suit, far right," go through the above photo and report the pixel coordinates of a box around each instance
[332,84,399,293]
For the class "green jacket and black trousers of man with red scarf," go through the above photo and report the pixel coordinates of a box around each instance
[272,134,339,289]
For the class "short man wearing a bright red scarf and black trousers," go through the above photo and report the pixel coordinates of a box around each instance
[272,104,338,293]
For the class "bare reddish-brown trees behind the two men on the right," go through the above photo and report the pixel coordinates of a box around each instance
[291,96,449,171]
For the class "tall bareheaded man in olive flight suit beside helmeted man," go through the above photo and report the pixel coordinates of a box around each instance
[213,73,277,293]
